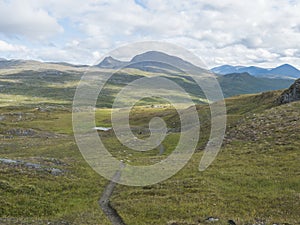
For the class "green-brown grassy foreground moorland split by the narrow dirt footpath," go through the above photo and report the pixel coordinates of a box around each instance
[0,85,300,225]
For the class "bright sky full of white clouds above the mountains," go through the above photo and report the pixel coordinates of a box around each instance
[0,0,300,68]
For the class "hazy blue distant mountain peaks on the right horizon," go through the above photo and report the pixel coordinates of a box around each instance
[211,64,300,79]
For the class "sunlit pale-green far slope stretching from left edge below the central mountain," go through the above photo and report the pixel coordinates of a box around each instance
[0,66,205,107]
